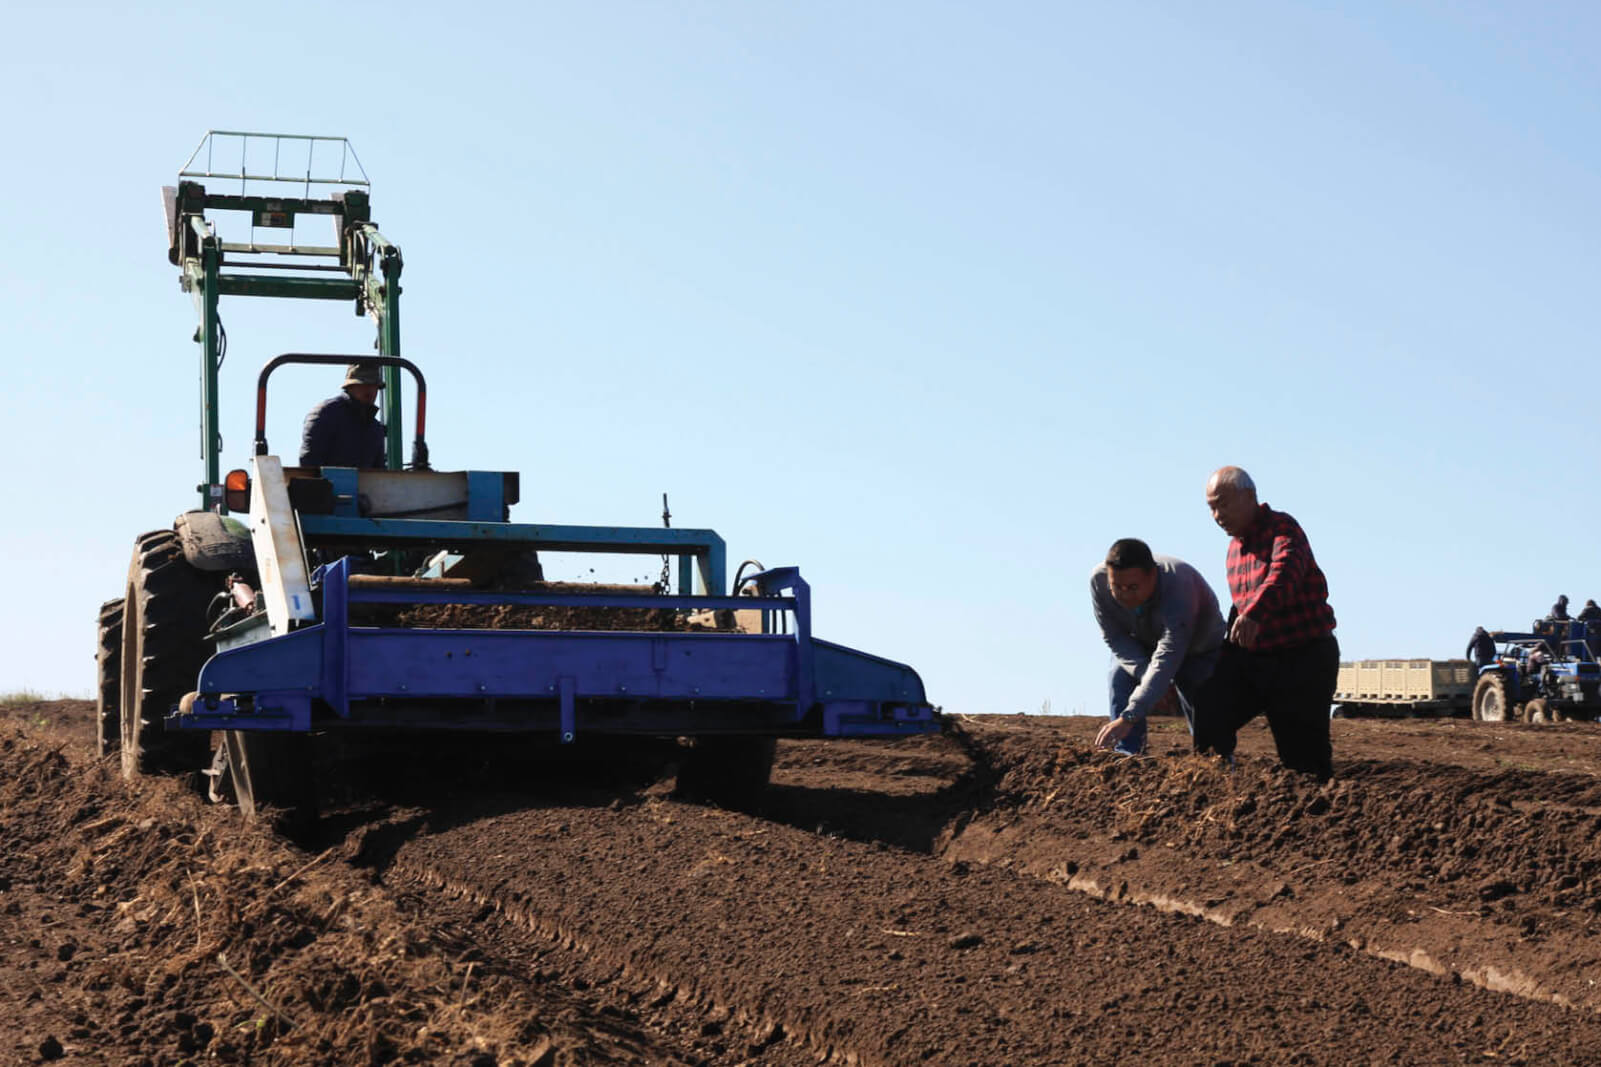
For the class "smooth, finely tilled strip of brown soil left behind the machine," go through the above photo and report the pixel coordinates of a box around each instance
[363,781,1601,1064]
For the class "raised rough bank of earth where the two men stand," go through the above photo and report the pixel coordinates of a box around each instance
[940,719,1601,1009]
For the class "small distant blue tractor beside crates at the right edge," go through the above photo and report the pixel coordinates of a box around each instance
[1473,618,1601,723]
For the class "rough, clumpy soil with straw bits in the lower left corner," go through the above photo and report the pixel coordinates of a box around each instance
[0,702,704,1067]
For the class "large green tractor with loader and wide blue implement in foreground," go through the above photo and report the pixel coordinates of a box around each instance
[98,131,940,814]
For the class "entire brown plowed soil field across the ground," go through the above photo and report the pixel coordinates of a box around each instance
[0,702,1601,1065]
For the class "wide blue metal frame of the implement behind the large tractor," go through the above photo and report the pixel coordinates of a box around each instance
[167,547,938,742]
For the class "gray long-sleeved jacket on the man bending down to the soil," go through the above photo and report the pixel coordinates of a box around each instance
[1090,556,1223,719]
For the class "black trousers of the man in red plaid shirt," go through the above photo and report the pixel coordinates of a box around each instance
[1194,633,1340,782]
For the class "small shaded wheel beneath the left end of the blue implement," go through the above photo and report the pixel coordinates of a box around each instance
[211,731,317,836]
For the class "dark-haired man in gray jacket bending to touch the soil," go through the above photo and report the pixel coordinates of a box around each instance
[1090,537,1225,756]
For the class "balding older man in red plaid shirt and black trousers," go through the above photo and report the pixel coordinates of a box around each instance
[1194,466,1340,782]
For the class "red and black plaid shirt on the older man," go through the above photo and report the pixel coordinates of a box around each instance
[1228,505,1334,650]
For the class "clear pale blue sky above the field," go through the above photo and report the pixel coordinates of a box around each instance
[0,0,1601,713]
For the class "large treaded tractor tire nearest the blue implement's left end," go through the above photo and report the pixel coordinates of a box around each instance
[117,530,223,779]
